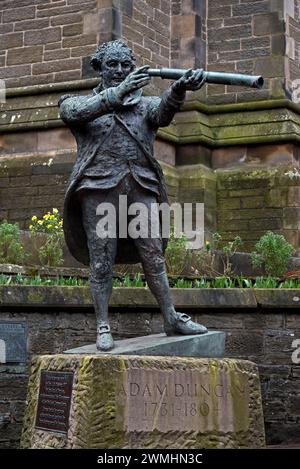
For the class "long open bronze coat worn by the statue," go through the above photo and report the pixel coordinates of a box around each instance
[59,88,184,265]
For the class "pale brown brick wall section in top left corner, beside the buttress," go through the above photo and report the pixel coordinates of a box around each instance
[0,0,97,87]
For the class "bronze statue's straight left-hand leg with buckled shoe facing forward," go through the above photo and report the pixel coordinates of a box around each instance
[81,191,117,351]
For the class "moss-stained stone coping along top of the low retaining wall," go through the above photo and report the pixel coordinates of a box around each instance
[0,285,300,311]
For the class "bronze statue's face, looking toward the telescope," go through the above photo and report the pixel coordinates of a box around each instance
[100,49,134,88]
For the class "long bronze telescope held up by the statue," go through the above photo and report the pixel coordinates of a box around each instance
[147,68,264,88]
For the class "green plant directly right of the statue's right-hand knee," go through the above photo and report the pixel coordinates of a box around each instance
[165,228,191,275]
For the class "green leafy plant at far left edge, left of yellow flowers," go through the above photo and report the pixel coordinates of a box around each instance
[0,221,26,264]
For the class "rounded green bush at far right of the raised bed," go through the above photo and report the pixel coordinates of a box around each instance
[251,231,293,277]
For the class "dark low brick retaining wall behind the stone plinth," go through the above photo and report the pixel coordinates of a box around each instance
[0,300,300,448]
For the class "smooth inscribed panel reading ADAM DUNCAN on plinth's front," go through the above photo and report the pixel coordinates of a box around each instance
[119,369,249,432]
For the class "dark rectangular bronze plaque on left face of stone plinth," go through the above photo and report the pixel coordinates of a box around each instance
[35,370,74,433]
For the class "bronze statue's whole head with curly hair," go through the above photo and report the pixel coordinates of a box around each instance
[91,39,135,88]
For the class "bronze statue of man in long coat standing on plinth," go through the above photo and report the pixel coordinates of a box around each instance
[59,40,207,351]
